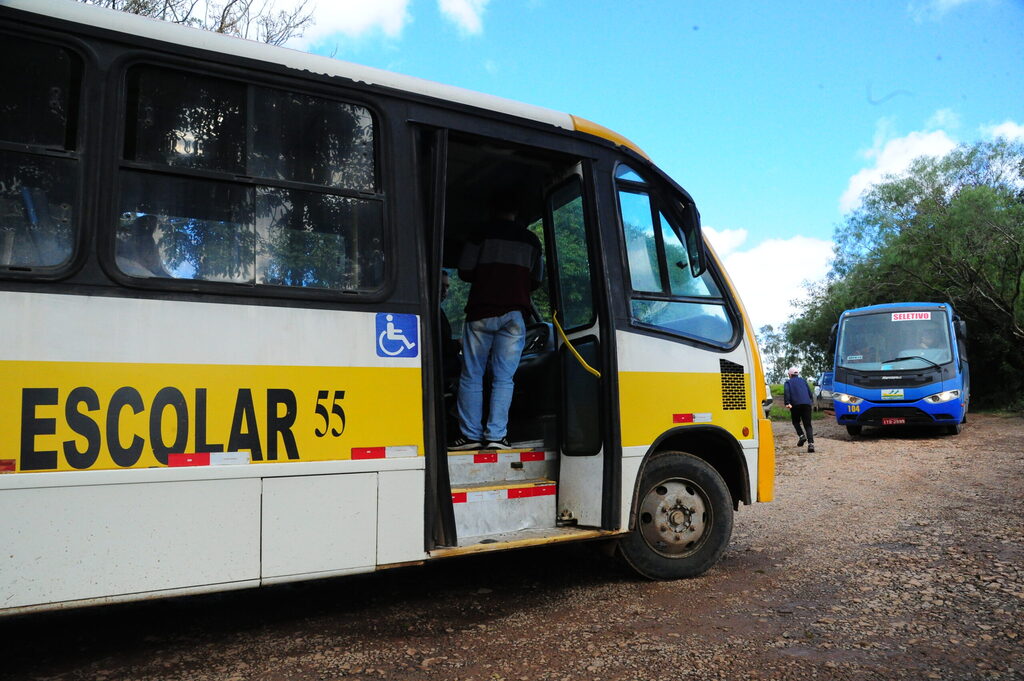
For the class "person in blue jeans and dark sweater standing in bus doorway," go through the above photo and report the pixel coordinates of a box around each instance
[449,189,544,451]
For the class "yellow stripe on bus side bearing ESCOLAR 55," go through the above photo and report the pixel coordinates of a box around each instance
[0,361,423,472]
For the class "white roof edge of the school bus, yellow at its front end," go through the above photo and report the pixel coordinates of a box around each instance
[0,0,647,158]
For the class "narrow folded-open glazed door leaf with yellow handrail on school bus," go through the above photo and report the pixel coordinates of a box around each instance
[545,165,608,527]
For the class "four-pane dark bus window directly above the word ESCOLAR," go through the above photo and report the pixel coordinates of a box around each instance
[116,66,385,292]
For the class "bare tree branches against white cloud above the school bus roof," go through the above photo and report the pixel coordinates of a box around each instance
[80,0,313,45]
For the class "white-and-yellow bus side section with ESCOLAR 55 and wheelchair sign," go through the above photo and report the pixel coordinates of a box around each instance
[0,292,423,473]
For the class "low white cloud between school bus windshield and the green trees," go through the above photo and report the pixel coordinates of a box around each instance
[703,226,833,331]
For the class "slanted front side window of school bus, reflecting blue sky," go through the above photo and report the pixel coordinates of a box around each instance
[616,166,735,346]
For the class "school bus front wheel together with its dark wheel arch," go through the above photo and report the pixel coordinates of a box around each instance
[618,427,750,580]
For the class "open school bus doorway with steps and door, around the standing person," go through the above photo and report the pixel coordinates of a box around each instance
[421,129,617,555]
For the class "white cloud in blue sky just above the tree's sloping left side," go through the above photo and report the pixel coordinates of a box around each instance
[839,122,956,213]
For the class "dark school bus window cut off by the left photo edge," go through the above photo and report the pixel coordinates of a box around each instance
[0,36,83,271]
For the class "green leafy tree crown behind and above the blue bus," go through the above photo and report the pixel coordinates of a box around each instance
[786,140,1024,406]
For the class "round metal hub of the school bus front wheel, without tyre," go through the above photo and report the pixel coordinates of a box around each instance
[640,480,712,558]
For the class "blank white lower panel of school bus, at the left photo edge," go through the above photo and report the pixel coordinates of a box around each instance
[0,478,261,608]
